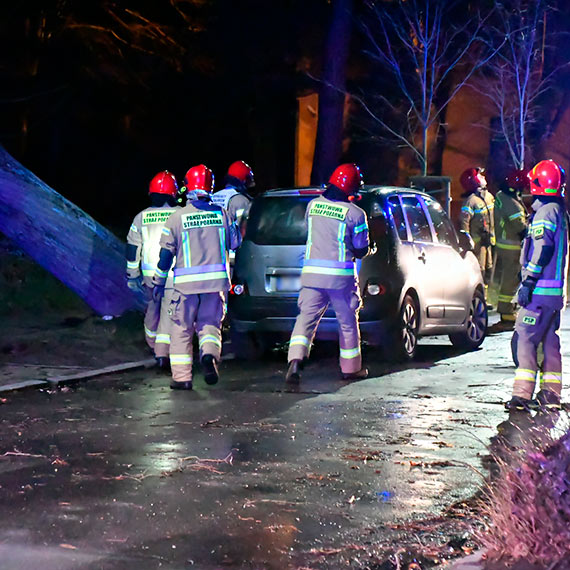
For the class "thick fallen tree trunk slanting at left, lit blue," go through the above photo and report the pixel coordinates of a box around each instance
[0,147,144,316]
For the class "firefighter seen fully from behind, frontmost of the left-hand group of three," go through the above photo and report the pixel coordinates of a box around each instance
[153,164,241,390]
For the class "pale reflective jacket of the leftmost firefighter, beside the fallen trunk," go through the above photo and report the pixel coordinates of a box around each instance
[127,204,179,288]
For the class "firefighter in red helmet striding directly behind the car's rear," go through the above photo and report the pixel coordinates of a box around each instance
[285,164,369,384]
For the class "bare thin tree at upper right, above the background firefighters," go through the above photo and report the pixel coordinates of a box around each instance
[472,0,564,169]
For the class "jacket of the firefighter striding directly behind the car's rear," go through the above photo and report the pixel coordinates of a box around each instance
[301,193,369,289]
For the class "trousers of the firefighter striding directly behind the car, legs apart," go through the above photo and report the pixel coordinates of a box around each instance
[287,284,362,373]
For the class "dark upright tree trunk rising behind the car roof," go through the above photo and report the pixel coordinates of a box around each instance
[311,0,352,184]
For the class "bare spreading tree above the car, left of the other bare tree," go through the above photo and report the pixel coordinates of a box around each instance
[360,0,496,175]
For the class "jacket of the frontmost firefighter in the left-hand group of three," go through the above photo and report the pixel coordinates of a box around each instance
[153,200,241,295]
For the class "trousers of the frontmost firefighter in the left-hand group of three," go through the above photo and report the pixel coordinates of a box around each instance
[169,291,226,382]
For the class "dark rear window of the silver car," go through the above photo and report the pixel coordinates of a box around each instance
[245,196,315,245]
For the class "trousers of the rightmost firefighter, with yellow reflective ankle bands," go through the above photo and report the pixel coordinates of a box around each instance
[513,306,562,400]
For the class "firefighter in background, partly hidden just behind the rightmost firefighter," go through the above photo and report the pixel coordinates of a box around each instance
[495,170,529,328]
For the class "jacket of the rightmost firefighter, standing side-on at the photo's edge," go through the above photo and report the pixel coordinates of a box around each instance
[521,199,568,309]
